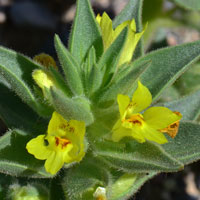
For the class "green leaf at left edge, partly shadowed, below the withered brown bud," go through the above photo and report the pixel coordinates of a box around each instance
[0,47,49,116]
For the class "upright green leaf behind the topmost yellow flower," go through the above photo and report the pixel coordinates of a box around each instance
[113,0,144,58]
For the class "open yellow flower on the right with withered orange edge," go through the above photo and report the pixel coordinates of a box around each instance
[112,81,182,144]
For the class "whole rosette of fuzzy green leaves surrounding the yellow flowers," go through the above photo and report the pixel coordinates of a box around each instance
[0,0,200,200]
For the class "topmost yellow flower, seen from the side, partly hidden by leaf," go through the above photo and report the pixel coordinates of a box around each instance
[96,12,144,65]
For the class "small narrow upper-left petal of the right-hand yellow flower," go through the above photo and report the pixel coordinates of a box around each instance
[117,94,130,119]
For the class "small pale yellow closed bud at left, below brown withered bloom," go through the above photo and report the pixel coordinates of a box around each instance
[32,69,54,91]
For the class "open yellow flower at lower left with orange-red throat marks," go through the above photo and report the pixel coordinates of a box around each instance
[26,112,85,174]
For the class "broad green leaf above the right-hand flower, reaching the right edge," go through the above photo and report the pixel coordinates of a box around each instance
[135,41,200,101]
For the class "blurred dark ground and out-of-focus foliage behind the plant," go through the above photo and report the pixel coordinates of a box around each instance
[0,0,200,200]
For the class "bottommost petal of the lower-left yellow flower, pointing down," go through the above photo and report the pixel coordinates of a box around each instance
[44,151,64,175]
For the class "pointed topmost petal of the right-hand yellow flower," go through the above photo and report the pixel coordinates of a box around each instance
[132,81,152,113]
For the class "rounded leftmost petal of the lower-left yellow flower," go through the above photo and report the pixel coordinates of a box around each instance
[26,135,51,160]
